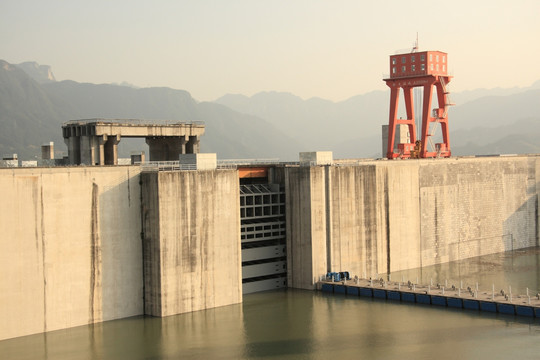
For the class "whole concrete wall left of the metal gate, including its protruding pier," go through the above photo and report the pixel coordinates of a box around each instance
[0,166,242,340]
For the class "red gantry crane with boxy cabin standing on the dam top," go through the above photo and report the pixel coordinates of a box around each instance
[384,46,453,159]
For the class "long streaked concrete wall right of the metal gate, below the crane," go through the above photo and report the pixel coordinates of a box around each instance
[284,156,540,289]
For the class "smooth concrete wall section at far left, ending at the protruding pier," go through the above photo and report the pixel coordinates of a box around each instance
[0,166,143,340]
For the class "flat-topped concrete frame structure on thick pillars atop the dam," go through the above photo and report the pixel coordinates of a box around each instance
[62,119,204,165]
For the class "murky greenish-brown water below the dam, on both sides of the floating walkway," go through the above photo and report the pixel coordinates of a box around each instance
[0,248,540,360]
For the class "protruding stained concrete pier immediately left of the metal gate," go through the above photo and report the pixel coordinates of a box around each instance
[141,170,242,316]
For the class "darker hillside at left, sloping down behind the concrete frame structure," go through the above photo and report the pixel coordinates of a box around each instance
[0,60,301,160]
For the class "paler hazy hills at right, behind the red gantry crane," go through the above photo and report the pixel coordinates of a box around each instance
[216,81,540,158]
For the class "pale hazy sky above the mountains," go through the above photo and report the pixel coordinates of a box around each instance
[0,0,540,101]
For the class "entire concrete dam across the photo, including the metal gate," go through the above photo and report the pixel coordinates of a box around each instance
[0,155,540,340]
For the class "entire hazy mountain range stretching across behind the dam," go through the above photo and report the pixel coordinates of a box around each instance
[0,60,540,160]
